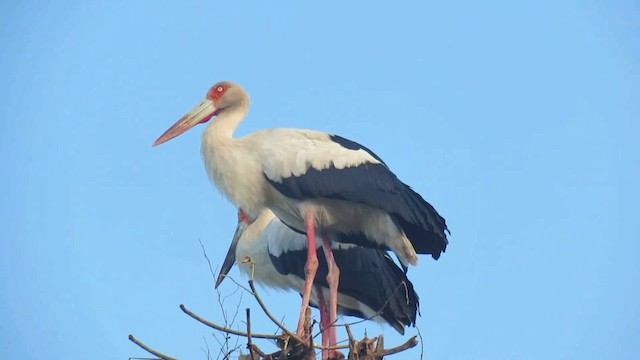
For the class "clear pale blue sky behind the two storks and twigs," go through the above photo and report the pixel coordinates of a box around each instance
[0,1,640,359]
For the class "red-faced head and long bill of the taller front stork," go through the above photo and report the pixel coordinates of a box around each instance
[153,81,249,146]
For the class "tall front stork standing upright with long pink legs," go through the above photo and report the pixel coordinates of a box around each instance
[153,81,448,352]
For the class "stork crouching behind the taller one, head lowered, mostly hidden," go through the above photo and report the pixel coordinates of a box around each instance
[216,209,418,346]
